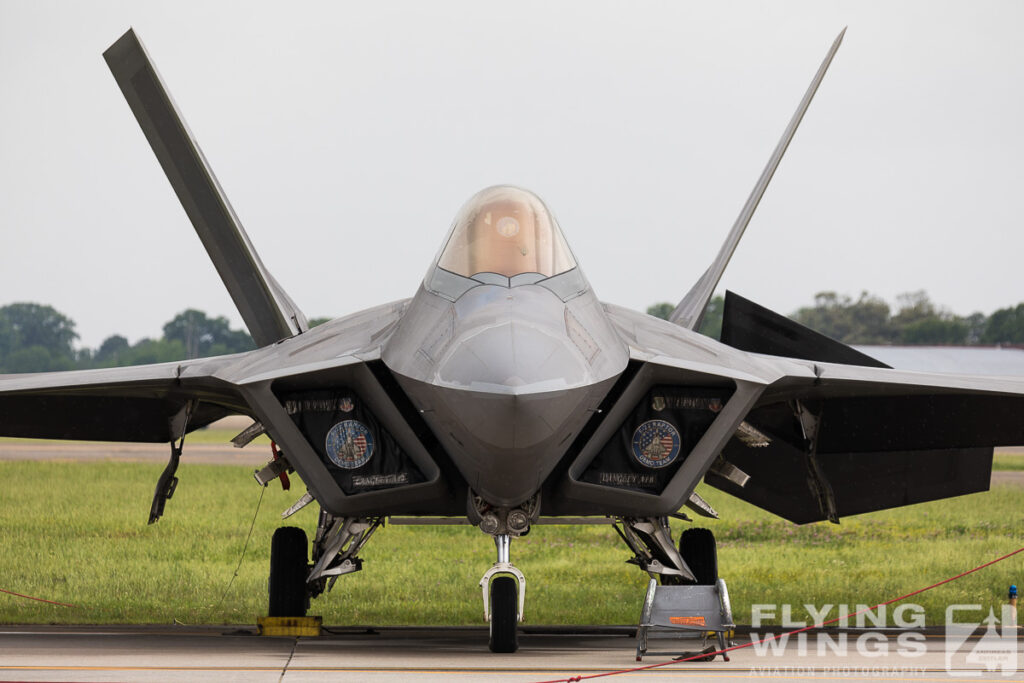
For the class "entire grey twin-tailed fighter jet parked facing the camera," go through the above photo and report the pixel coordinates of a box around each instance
[0,31,1024,652]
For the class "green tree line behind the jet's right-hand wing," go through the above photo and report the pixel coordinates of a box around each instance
[647,291,1024,346]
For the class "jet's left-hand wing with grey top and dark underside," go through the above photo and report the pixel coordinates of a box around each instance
[0,300,408,442]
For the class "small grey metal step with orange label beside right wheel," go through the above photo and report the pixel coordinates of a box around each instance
[637,579,736,661]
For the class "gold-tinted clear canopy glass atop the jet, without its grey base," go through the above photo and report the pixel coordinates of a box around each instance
[437,186,577,279]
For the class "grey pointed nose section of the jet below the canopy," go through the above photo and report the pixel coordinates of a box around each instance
[382,284,629,506]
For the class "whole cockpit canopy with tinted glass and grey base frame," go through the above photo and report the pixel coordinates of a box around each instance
[425,185,586,300]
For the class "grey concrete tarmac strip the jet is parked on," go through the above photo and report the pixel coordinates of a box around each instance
[0,626,1024,683]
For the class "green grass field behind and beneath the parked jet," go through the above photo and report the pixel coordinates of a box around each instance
[0,461,1024,625]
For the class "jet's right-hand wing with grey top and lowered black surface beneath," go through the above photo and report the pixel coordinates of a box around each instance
[593,306,1024,523]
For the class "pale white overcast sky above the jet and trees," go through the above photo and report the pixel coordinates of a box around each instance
[0,0,1024,346]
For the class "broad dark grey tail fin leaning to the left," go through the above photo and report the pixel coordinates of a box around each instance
[103,30,307,346]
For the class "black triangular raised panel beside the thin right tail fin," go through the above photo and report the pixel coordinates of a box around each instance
[721,292,889,368]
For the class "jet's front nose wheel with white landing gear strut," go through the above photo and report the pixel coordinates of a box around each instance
[480,533,526,652]
